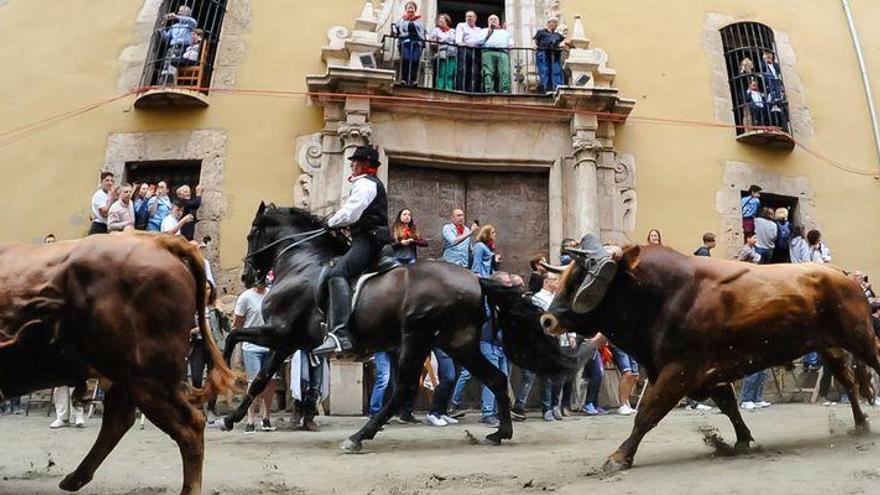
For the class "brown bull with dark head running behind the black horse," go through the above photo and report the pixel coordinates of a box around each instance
[541,246,880,469]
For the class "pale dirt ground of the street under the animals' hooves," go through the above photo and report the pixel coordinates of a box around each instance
[0,404,880,495]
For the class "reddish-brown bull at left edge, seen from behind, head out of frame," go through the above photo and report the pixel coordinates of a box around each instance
[0,234,234,494]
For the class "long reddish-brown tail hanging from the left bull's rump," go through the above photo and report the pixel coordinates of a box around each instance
[157,236,241,405]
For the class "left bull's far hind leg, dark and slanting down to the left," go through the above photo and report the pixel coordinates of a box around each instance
[58,385,135,492]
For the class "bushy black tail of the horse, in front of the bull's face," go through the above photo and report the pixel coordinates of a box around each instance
[480,278,578,376]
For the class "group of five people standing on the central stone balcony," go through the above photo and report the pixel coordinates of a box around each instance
[391,2,567,93]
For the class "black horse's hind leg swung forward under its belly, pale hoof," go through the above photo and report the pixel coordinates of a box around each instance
[342,335,431,452]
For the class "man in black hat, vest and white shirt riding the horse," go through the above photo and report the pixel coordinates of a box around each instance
[312,146,391,354]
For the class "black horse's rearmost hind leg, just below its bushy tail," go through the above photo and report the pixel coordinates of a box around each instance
[444,338,513,445]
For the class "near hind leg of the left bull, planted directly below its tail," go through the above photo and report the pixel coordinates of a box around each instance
[131,380,205,495]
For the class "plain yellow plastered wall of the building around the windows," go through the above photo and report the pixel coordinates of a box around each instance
[0,0,880,276]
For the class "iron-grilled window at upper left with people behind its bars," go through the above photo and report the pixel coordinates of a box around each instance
[141,0,226,94]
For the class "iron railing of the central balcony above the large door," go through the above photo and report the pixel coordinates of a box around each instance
[378,35,568,95]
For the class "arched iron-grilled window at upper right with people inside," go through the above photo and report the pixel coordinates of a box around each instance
[721,22,791,136]
